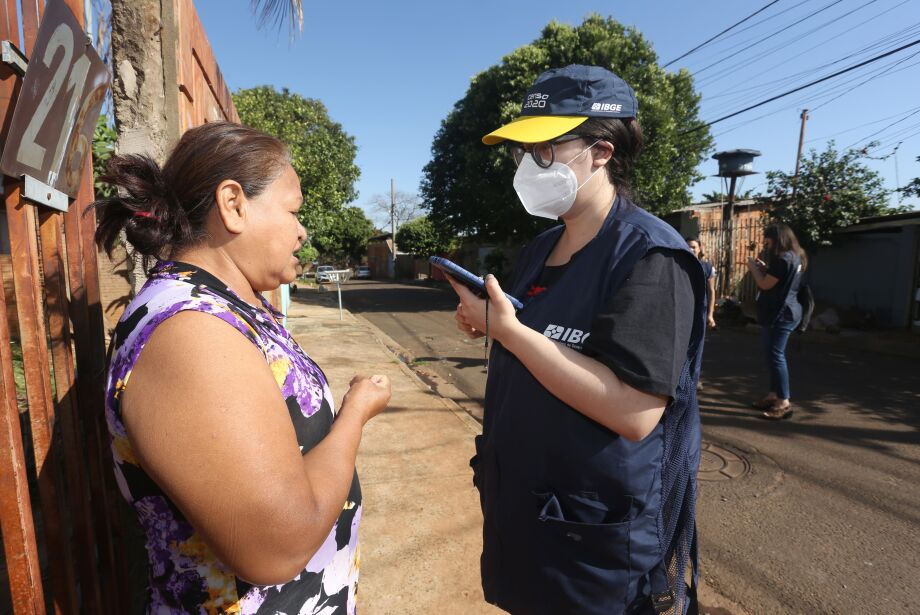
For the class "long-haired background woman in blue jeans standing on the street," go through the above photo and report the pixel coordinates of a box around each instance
[747,224,808,420]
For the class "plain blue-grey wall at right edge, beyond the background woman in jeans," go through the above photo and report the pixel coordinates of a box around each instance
[809,226,920,328]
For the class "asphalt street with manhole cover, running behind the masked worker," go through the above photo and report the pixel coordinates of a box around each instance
[334,282,920,614]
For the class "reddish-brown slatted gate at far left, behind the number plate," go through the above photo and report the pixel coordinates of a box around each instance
[0,0,127,615]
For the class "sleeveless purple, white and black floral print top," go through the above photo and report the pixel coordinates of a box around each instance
[105,262,361,615]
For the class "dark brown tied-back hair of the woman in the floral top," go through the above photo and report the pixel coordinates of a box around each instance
[90,122,289,265]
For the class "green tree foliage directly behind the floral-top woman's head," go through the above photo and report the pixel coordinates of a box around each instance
[233,86,369,260]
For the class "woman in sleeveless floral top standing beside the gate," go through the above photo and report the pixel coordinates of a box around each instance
[94,123,390,615]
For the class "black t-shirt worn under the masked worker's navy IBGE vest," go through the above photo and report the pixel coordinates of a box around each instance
[528,250,699,397]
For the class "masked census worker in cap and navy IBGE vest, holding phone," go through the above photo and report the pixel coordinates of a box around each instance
[452,66,705,615]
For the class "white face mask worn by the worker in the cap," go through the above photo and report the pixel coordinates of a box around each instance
[513,141,604,220]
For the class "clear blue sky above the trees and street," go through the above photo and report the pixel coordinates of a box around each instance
[196,0,920,226]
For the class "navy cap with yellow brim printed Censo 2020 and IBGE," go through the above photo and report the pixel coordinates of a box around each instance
[482,64,639,145]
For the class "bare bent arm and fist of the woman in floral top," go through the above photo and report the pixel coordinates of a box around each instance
[122,312,390,585]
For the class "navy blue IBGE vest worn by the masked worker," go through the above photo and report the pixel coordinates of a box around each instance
[471,197,705,615]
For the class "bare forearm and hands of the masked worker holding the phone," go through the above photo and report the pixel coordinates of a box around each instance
[448,276,668,441]
